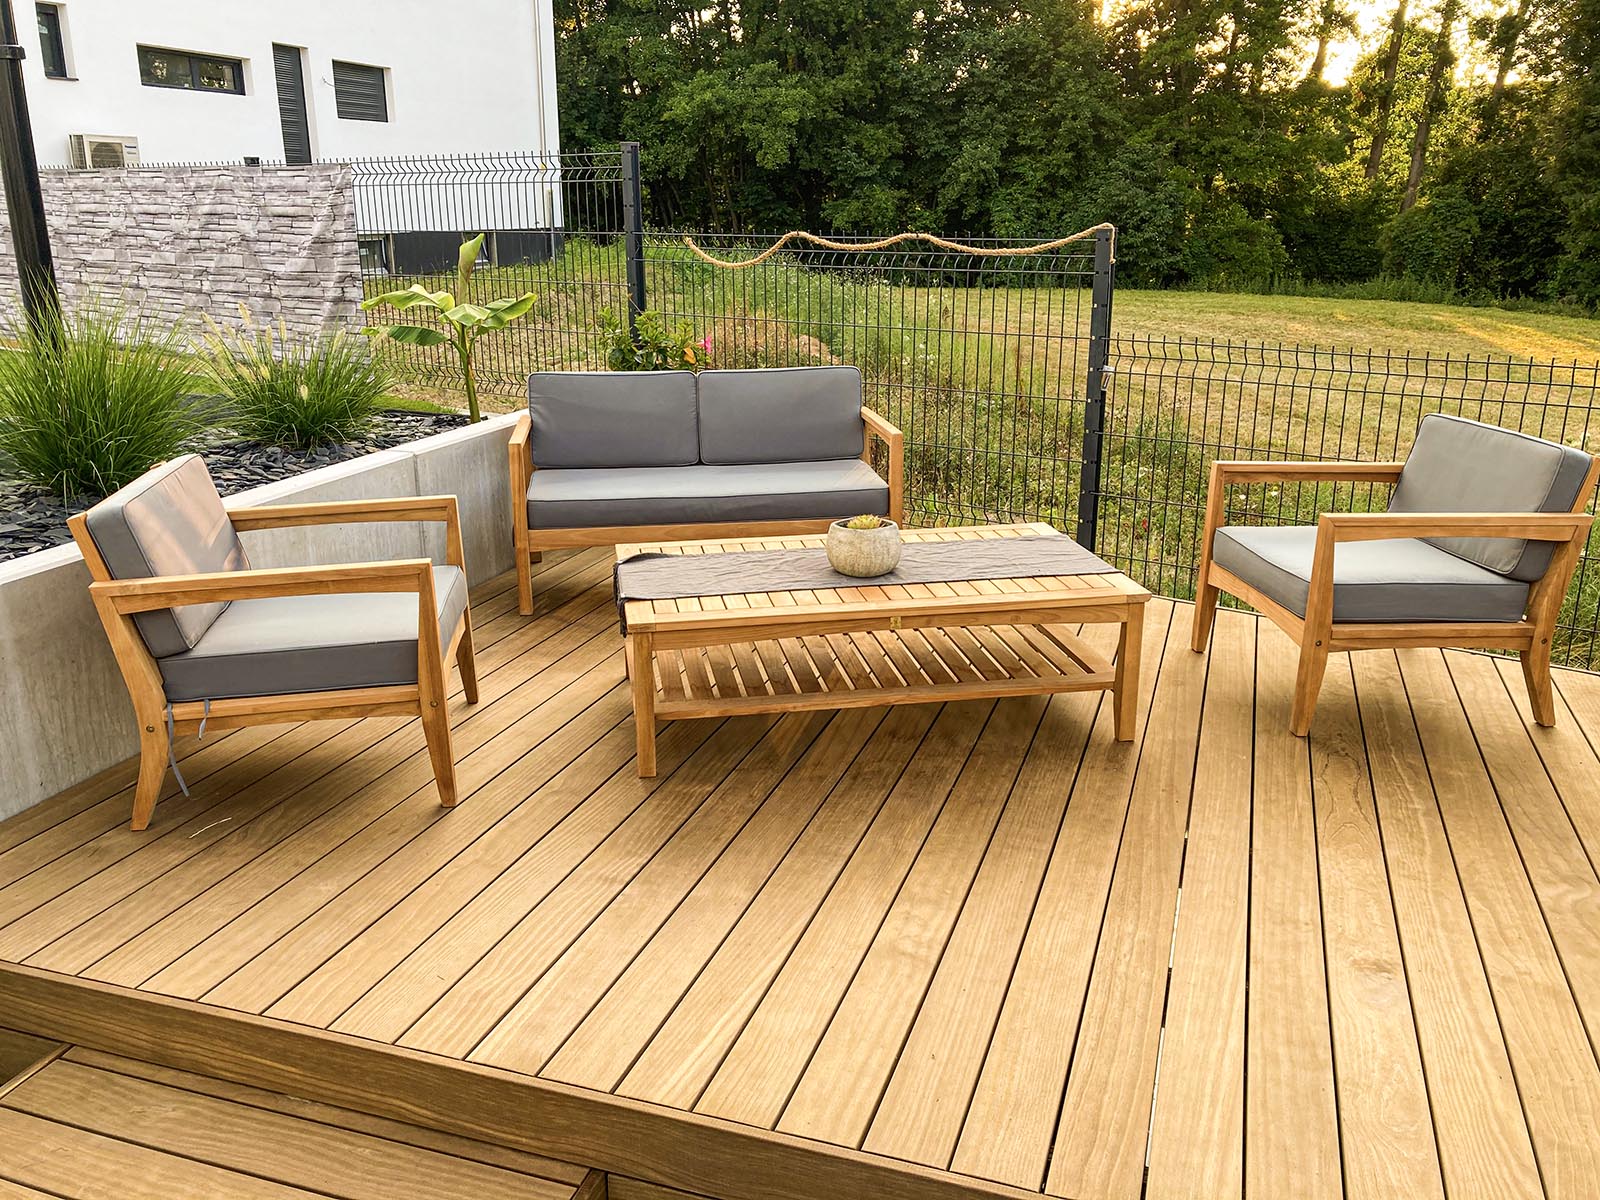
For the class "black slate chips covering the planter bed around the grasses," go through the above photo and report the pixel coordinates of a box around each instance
[0,413,467,562]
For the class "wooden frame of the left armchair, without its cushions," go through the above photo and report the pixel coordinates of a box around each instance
[67,496,478,830]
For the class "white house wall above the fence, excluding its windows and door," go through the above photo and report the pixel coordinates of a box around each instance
[18,0,560,165]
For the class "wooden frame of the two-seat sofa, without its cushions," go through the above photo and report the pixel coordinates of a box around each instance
[507,408,906,616]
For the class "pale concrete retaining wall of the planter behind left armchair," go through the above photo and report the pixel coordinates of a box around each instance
[0,416,515,818]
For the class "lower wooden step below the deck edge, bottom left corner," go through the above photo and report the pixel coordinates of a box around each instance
[0,1048,603,1200]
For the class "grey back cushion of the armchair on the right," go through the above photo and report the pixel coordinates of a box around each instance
[1389,413,1590,582]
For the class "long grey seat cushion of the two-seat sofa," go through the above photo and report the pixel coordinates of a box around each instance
[528,459,890,530]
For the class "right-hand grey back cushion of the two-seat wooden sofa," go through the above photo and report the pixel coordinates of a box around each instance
[699,366,866,466]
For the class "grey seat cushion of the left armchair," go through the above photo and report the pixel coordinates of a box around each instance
[158,566,467,701]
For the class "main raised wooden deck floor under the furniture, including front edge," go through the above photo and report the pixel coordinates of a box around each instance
[0,552,1600,1200]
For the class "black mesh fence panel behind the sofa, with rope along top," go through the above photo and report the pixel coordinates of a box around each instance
[645,232,1094,531]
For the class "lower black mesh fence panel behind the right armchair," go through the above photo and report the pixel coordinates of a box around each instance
[1098,338,1600,667]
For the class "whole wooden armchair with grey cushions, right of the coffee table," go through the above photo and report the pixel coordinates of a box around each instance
[1190,414,1600,736]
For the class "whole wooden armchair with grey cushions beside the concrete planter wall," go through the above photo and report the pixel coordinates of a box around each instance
[69,454,478,829]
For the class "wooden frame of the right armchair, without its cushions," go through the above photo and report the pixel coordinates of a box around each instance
[1189,459,1600,738]
